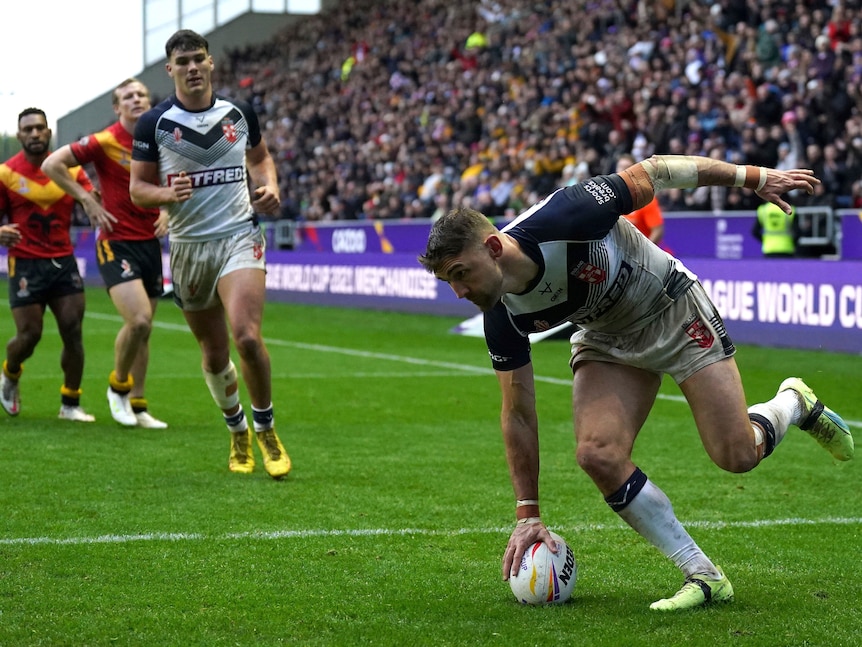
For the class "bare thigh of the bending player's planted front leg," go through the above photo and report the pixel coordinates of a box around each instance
[572,361,661,458]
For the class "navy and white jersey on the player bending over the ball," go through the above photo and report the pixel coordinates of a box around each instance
[485,175,697,371]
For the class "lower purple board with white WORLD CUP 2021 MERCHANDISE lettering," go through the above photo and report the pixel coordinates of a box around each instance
[260,252,862,353]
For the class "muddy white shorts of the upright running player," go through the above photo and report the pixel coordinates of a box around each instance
[171,226,266,311]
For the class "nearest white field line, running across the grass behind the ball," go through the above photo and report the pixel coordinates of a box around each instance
[0,517,862,546]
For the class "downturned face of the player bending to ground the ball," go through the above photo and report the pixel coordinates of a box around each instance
[437,245,503,312]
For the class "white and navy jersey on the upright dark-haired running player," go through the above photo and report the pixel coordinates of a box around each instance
[132,95,261,242]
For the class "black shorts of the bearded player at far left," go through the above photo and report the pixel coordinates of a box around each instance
[9,254,84,308]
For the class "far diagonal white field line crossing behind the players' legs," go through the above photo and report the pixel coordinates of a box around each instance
[86,312,862,428]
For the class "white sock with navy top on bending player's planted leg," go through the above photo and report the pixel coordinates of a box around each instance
[605,468,720,579]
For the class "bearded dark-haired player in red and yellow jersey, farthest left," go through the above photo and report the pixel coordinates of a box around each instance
[0,108,94,422]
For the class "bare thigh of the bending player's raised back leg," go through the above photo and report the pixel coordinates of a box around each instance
[679,357,754,471]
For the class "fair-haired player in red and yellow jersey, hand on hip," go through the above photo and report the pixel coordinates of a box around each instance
[42,78,167,429]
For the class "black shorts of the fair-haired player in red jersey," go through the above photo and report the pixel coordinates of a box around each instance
[96,238,164,298]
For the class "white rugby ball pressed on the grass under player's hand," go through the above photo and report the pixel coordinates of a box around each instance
[509,532,578,605]
